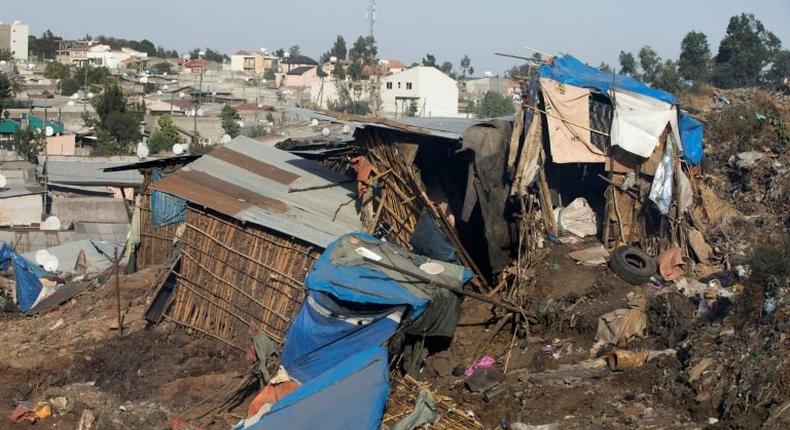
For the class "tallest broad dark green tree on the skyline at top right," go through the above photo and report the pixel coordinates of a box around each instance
[712,13,781,88]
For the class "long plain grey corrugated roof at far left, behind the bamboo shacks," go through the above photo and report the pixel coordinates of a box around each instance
[39,155,143,186]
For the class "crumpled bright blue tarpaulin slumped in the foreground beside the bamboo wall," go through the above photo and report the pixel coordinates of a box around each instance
[236,233,468,430]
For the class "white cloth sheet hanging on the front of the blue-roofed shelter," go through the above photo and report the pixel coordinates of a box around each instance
[610,91,679,158]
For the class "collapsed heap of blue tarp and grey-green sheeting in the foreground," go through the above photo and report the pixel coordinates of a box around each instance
[236,233,471,429]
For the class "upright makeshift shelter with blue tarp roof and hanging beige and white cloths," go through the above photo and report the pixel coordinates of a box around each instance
[507,55,702,254]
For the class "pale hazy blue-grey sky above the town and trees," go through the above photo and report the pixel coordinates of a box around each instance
[0,0,790,74]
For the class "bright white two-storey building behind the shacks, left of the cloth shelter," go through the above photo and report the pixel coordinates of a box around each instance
[381,66,458,117]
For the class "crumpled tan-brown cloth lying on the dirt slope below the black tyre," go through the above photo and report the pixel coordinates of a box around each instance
[595,292,647,347]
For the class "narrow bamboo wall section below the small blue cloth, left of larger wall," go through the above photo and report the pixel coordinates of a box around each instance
[137,191,183,269]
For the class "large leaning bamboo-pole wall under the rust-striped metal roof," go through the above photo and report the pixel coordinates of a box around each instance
[165,206,321,351]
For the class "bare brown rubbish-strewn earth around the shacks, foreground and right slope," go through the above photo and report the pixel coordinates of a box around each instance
[0,90,790,430]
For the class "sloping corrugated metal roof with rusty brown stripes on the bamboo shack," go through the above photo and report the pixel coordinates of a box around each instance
[152,136,361,247]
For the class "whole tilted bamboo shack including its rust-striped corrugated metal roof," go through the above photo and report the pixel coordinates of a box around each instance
[141,137,360,351]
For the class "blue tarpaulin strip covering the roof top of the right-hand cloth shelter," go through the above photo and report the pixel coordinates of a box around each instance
[538,55,678,104]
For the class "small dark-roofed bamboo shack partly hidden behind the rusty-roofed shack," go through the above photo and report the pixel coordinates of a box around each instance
[104,155,200,269]
